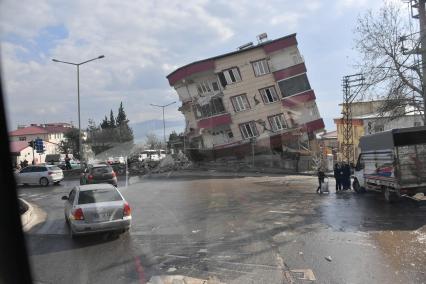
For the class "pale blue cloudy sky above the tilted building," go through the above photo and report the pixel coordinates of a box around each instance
[0,0,406,130]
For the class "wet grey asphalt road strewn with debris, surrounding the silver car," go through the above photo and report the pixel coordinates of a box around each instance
[19,174,426,283]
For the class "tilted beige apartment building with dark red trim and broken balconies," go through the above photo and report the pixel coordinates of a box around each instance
[167,34,324,158]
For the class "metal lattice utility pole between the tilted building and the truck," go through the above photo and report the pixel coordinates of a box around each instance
[341,74,364,164]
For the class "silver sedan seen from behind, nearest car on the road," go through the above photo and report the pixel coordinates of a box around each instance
[62,184,132,238]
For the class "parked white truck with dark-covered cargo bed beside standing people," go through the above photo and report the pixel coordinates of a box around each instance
[353,126,426,202]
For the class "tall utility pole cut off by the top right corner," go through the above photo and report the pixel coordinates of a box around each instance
[410,0,426,121]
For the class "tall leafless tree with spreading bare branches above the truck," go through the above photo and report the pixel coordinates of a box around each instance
[355,1,426,122]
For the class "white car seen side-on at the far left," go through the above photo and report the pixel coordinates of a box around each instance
[16,165,64,186]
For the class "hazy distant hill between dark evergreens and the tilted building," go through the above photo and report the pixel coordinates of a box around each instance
[129,119,185,143]
